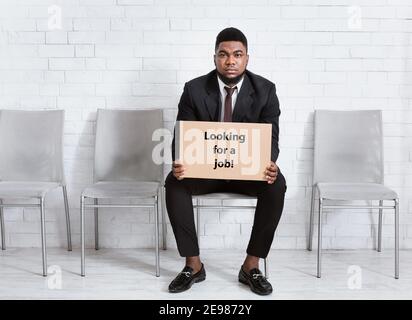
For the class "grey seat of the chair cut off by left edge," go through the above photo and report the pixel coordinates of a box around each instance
[0,181,60,199]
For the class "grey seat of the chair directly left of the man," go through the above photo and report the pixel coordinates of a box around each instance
[82,181,160,198]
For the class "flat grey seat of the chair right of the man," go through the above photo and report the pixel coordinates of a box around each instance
[317,182,398,200]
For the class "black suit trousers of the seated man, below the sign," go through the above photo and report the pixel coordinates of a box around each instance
[165,171,286,258]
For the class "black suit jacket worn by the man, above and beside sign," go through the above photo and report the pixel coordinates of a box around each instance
[172,70,280,162]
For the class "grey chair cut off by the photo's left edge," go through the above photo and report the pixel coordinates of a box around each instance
[0,110,72,276]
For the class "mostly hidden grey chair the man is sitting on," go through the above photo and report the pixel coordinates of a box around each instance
[193,192,269,278]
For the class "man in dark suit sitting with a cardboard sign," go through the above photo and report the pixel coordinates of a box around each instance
[165,28,286,295]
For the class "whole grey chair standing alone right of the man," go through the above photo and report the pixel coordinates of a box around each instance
[308,110,399,279]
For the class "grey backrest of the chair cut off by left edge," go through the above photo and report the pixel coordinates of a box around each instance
[0,110,65,184]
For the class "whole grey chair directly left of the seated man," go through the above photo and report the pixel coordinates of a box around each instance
[80,109,163,277]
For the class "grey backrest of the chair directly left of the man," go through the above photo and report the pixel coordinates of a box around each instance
[94,109,163,182]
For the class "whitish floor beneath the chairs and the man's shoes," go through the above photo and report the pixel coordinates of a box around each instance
[0,248,412,300]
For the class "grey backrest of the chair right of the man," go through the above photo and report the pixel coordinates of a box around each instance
[313,110,384,184]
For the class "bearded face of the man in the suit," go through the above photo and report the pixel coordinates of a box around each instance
[214,41,249,80]
